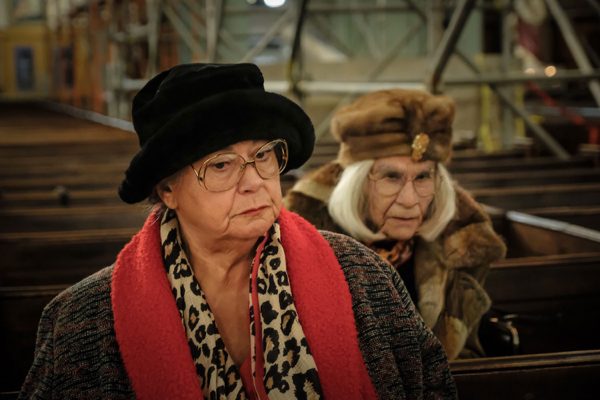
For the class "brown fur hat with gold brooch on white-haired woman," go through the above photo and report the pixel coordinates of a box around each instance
[331,89,456,167]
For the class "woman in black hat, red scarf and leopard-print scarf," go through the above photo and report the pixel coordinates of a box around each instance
[20,64,456,400]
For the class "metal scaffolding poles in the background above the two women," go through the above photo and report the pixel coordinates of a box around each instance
[48,0,600,159]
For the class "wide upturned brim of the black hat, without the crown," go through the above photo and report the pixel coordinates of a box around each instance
[119,89,315,204]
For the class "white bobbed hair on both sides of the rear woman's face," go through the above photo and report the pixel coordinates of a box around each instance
[327,160,456,242]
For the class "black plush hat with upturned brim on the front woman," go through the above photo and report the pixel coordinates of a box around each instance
[119,64,315,204]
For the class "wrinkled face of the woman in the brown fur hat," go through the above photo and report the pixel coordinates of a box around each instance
[365,156,435,241]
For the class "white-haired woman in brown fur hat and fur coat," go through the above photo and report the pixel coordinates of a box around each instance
[284,89,505,360]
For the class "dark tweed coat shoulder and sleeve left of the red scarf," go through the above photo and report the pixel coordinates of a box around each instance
[19,267,135,400]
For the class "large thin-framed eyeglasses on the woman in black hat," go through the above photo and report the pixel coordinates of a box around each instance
[191,139,288,192]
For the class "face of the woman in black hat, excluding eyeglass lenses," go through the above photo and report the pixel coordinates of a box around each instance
[161,140,282,240]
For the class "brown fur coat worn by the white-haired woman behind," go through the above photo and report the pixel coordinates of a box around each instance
[284,162,506,360]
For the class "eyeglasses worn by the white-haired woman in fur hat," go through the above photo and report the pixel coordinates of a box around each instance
[369,170,435,197]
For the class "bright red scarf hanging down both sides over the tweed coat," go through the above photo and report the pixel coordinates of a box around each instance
[111,209,377,400]
